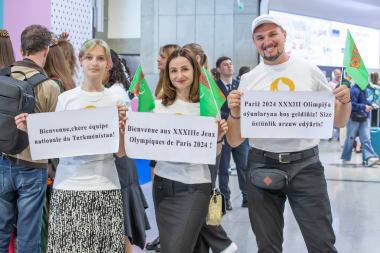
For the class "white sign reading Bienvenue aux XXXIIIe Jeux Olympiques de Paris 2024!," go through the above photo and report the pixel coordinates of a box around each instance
[125,112,218,164]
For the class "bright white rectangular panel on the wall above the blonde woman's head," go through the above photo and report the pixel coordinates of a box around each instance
[108,0,141,39]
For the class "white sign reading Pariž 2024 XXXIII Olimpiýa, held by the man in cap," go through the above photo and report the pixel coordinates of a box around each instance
[241,91,335,139]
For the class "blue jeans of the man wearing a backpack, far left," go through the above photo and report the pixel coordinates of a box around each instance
[0,155,47,253]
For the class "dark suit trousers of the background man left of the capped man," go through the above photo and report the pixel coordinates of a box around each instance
[219,140,247,199]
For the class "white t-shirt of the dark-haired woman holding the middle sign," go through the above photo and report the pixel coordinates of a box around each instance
[153,98,216,184]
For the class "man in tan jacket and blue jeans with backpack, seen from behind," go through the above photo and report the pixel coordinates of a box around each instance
[0,25,60,253]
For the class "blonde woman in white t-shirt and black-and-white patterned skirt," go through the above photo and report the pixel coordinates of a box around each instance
[16,39,128,253]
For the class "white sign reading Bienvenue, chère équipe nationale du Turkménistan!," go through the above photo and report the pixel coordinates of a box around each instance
[27,106,119,160]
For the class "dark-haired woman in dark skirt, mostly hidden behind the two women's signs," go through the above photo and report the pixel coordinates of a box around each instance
[102,49,150,253]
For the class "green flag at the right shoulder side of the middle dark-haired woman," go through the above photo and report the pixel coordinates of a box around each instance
[199,68,226,118]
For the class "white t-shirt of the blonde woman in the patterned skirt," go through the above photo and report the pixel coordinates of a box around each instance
[53,87,123,191]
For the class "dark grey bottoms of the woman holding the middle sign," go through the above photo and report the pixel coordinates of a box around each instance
[153,175,211,253]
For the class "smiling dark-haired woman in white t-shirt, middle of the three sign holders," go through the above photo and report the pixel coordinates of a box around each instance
[153,49,228,253]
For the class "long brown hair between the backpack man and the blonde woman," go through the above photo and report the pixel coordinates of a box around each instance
[44,46,76,90]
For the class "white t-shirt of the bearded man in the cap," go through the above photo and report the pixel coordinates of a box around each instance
[239,57,331,153]
